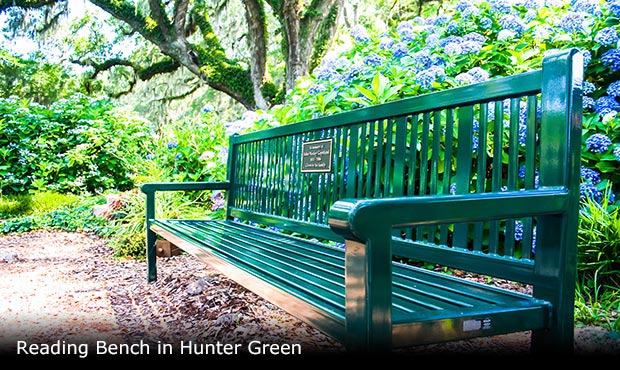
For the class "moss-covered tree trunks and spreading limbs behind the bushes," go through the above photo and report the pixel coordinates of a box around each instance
[0,0,343,109]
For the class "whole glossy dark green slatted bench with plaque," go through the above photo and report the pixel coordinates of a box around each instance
[142,50,583,352]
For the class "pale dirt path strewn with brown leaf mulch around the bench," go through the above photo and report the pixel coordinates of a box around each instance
[0,231,620,357]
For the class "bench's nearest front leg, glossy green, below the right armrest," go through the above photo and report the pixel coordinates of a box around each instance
[345,236,392,352]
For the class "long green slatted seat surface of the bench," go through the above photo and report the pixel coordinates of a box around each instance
[152,220,548,343]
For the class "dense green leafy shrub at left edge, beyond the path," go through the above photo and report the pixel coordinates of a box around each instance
[0,95,148,195]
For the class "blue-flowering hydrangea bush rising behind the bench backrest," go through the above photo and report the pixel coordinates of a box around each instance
[231,0,620,208]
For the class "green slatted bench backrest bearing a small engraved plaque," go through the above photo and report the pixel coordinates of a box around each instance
[228,50,583,282]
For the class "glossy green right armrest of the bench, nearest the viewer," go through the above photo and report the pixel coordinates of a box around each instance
[329,188,569,241]
